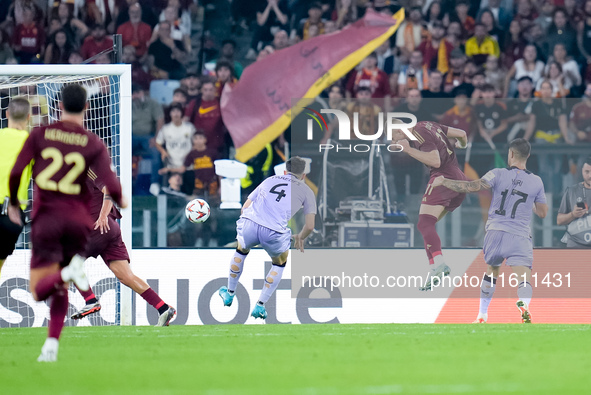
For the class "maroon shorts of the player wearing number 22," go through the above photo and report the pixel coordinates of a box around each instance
[31,212,92,269]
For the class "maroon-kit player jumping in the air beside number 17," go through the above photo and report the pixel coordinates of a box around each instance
[392,121,468,290]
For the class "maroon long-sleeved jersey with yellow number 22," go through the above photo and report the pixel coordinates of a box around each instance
[10,122,121,219]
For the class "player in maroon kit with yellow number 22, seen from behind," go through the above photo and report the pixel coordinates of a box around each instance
[9,84,127,362]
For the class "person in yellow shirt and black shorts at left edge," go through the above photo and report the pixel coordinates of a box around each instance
[0,97,31,276]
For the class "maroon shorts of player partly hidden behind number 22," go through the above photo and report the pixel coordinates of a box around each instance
[86,217,129,265]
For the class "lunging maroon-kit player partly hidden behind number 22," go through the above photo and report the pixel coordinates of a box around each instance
[70,169,176,326]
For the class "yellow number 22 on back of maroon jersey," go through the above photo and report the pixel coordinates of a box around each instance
[35,147,86,195]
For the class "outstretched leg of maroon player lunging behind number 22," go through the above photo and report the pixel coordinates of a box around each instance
[109,260,176,326]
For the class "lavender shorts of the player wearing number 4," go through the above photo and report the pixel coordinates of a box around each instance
[236,218,291,258]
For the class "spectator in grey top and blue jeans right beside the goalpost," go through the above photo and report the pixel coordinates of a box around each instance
[131,84,164,195]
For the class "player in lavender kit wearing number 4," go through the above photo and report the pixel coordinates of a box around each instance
[219,156,316,319]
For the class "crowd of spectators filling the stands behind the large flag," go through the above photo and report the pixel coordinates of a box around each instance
[0,0,591,248]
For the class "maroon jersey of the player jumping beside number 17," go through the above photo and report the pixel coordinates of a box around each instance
[411,121,466,180]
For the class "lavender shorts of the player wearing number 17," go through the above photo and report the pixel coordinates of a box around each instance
[482,230,534,269]
